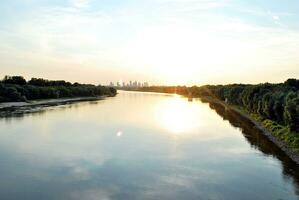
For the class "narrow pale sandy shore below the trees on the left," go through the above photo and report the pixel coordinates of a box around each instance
[0,95,108,117]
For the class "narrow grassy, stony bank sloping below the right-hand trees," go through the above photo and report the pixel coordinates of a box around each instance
[200,97,299,164]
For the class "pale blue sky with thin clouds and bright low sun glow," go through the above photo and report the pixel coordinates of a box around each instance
[0,0,299,85]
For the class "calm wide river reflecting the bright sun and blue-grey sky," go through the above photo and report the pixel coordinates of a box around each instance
[0,92,299,200]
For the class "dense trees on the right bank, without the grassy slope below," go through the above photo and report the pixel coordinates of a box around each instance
[191,79,299,132]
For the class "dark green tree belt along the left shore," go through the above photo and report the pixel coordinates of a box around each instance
[0,76,116,102]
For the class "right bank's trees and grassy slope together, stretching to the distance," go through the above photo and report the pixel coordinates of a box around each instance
[140,79,299,151]
